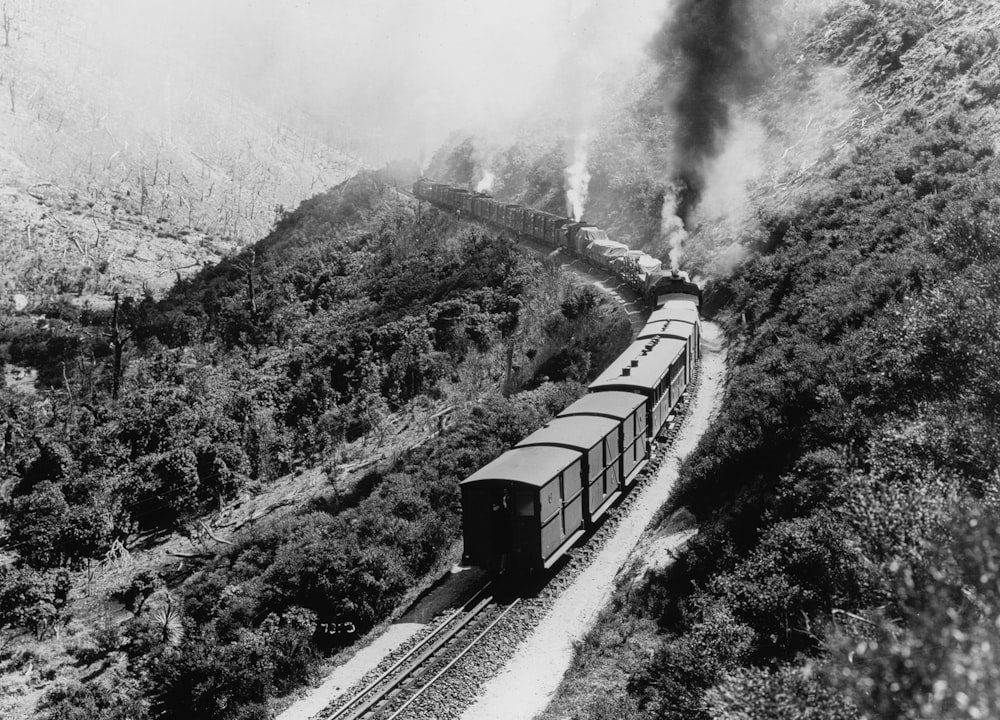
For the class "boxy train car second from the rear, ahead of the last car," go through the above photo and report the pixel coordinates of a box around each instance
[517,416,624,528]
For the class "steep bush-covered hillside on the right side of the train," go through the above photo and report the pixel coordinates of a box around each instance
[551,2,1000,720]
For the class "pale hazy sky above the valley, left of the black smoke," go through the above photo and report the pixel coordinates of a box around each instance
[91,0,670,160]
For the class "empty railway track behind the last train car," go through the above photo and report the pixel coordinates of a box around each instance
[317,583,521,720]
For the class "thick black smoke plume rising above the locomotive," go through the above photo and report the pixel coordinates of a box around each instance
[653,0,775,229]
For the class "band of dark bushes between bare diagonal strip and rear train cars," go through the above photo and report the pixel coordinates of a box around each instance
[140,384,581,718]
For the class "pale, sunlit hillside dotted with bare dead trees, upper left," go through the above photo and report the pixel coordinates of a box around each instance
[0,0,357,306]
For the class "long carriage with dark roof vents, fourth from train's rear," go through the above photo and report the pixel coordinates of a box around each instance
[588,337,688,438]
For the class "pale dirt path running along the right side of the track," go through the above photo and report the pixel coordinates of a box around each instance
[463,323,726,720]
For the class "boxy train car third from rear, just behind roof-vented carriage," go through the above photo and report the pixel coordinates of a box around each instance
[559,390,649,489]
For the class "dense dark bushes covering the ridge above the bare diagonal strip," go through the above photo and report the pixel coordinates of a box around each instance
[5,175,608,556]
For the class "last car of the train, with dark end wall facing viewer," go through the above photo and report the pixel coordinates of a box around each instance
[459,446,584,573]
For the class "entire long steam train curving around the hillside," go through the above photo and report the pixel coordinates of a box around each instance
[413,179,701,575]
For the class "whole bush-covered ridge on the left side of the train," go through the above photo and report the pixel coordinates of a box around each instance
[0,174,630,719]
